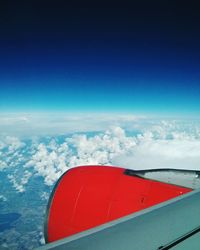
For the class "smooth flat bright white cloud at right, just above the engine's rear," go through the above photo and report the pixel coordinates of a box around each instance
[113,128,200,170]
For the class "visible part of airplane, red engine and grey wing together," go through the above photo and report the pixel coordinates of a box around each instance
[35,166,200,250]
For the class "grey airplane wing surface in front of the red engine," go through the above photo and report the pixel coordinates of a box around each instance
[38,190,200,250]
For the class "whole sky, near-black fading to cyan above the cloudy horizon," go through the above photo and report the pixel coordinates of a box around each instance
[0,0,200,114]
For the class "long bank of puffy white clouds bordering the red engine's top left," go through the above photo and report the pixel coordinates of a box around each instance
[25,127,135,185]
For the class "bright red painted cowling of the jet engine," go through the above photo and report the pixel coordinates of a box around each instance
[47,166,191,242]
